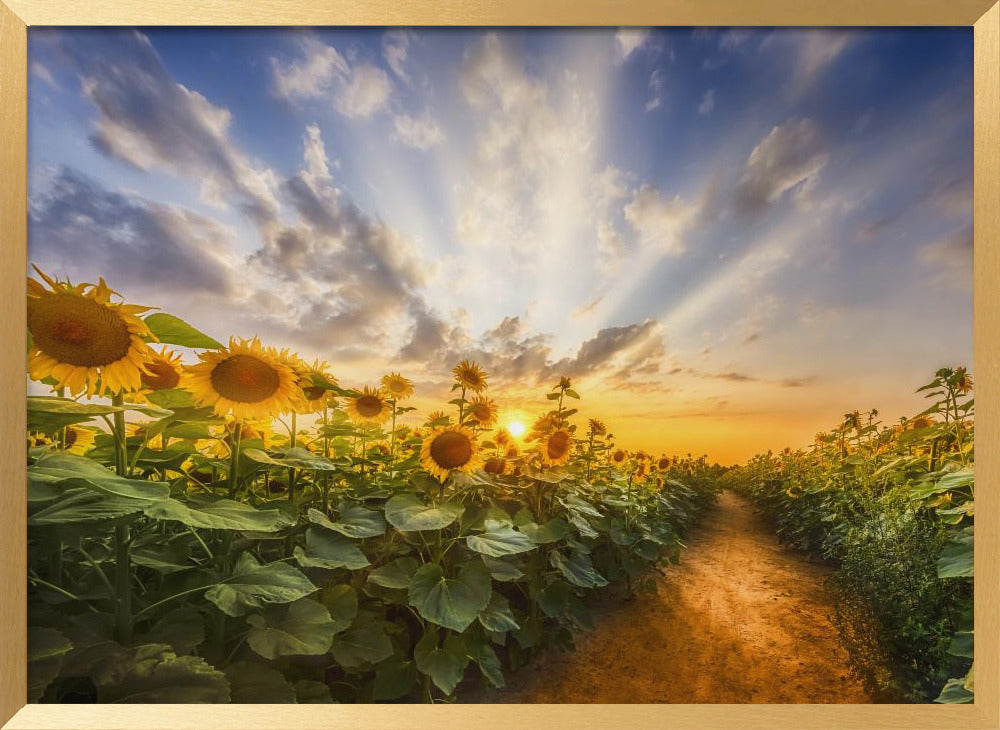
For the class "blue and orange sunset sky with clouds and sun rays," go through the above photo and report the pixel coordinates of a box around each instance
[28,28,973,463]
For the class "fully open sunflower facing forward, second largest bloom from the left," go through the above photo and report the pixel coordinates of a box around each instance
[181,337,303,421]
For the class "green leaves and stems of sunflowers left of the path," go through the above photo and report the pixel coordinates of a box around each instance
[28,372,721,703]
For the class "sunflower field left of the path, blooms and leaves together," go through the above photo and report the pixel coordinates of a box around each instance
[27,272,724,703]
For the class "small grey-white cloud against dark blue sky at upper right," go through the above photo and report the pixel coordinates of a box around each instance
[736,118,828,213]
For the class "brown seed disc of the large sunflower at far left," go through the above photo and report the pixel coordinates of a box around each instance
[28,294,132,367]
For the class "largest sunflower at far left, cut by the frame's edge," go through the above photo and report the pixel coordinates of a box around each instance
[28,267,155,397]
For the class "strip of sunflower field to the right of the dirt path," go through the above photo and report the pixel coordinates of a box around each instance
[722,367,975,703]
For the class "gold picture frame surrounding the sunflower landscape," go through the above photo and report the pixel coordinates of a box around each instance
[0,0,1000,730]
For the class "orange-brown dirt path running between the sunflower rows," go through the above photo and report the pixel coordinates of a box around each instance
[483,492,872,703]
